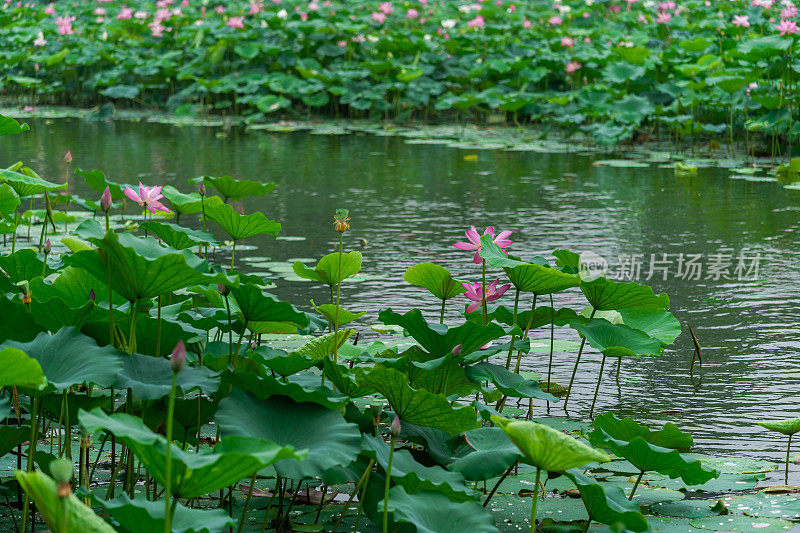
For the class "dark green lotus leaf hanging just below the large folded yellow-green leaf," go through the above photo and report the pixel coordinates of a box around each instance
[566,469,650,531]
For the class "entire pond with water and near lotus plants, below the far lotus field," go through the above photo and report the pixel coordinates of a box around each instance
[0,113,800,532]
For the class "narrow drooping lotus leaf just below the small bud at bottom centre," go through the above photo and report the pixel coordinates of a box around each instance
[364,435,475,502]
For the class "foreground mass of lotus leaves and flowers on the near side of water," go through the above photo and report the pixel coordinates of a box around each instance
[0,113,800,533]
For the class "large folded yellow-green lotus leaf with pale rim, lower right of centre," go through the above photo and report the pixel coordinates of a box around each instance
[492,416,611,472]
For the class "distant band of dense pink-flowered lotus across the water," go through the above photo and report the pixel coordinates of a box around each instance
[0,0,800,148]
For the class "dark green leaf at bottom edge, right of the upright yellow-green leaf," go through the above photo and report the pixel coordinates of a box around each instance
[90,492,236,533]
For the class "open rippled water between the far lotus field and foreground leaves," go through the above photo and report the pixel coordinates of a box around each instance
[0,120,800,468]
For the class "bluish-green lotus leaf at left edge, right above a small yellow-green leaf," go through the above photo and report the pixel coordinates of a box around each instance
[2,328,124,391]
